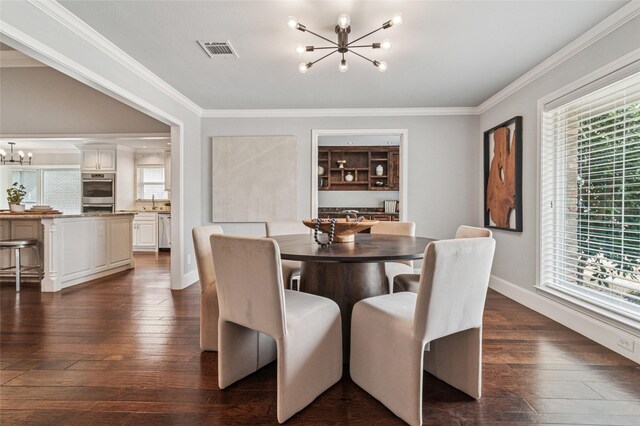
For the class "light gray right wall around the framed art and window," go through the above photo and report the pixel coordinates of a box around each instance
[477,18,640,291]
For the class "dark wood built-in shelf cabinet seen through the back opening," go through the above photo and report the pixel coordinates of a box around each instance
[318,146,400,191]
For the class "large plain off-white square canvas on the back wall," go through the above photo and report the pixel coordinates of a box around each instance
[211,136,298,222]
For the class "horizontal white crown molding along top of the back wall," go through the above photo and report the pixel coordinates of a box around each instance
[202,107,478,118]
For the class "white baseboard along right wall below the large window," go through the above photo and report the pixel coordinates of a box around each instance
[489,275,640,364]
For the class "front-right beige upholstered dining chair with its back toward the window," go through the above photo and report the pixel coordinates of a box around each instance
[350,238,495,425]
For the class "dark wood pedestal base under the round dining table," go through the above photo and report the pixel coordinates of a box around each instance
[300,261,387,364]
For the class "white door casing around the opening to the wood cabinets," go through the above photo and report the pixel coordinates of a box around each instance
[310,129,409,221]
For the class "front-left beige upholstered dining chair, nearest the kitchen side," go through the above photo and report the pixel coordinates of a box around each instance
[211,234,342,423]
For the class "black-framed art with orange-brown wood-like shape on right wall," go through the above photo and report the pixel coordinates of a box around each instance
[484,116,522,232]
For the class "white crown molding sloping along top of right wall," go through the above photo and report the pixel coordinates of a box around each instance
[477,0,640,114]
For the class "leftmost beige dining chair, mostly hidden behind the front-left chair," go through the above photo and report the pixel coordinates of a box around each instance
[192,225,223,351]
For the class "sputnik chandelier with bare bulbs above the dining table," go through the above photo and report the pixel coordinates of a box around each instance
[287,13,402,74]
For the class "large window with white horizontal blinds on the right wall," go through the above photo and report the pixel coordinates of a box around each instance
[540,70,640,320]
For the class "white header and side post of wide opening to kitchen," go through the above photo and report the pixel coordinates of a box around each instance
[0,1,202,289]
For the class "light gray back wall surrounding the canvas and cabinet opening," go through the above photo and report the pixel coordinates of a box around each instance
[201,116,480,238]
